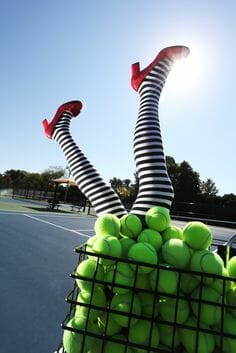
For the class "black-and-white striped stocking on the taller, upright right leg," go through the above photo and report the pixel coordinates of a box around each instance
[131,58,174,215]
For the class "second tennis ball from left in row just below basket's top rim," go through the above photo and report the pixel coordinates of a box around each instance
[104,262,134,294]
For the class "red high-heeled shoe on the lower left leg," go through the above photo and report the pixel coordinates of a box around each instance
[43,101,83,139]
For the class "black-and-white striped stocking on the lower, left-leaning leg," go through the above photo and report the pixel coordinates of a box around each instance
[52,112,127,217]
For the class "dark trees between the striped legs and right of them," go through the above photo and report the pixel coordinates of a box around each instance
[110,156,236,220]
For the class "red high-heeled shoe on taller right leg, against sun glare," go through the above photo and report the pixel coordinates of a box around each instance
[131,45,190,91]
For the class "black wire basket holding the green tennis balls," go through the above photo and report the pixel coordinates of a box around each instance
[56,236,236,353]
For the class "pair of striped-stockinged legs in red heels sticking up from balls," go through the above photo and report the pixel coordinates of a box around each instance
[43,46,189,218]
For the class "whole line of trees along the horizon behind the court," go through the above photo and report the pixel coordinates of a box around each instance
[0,156,236,219]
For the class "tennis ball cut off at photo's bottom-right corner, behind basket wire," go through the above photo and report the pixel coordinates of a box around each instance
[216,312,236,353]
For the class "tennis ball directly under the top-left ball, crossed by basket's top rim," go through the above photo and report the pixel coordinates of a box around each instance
[93,235,122,266]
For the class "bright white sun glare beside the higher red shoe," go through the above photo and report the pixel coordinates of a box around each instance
[163,47,203,94]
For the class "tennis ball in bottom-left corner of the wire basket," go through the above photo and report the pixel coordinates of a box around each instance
[63,315,94,353]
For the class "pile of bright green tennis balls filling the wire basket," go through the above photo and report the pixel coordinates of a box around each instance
[63,207,236,353]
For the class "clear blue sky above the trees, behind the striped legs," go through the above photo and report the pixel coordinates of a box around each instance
[0,0,236,195]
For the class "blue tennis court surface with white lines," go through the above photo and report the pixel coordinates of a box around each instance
[0,204,233,353]
